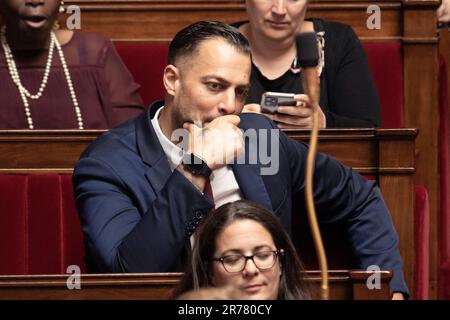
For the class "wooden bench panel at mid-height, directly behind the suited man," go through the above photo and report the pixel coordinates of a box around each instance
[0,129,417,174]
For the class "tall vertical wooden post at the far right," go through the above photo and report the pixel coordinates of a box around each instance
[403,0,439,298]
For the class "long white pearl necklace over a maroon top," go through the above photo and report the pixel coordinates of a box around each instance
[0,26,84,129]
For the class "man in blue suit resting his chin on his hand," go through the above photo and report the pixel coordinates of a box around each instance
[73,22,408,294]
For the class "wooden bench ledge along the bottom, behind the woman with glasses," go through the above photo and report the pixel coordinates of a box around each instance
[0,270,392,300]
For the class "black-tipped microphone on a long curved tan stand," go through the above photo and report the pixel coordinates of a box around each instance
[296,32,329,300]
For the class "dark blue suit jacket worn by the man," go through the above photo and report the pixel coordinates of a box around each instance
[73,104,408,293]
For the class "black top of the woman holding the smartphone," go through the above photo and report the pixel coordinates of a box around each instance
[233,19,381,128]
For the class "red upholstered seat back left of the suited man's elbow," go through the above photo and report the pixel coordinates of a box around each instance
[0,174,85,274]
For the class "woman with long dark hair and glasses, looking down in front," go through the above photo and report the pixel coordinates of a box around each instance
[174,200,308,300]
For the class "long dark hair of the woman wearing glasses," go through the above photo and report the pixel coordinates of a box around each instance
[173,200,309,300]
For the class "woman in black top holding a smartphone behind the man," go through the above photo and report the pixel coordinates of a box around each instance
[234,0,381,128]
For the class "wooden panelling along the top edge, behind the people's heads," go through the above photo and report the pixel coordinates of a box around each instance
[57,0,402,41]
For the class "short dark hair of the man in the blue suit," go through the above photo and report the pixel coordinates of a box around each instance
[168,21,250,64]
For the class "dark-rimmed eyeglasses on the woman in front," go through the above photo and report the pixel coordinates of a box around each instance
[212,249,284,273]
